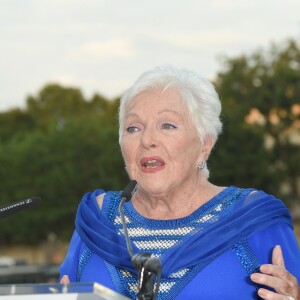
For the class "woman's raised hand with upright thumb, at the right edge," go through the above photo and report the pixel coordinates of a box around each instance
[250,246,300,300]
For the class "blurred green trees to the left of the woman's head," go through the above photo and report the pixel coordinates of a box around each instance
[0,85,128,245]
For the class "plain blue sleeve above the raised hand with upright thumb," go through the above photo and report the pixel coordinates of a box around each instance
[249,224,300,282]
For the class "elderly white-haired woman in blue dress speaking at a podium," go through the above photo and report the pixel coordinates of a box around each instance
[61,66,300,300]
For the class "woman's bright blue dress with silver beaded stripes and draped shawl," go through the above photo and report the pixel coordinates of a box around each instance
[60,186,300,299]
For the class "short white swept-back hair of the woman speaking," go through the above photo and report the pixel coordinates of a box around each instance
[119,65,222,177]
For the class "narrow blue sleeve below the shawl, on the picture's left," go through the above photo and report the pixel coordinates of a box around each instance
[59,231,83,282]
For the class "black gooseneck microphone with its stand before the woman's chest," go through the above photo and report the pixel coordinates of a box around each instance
[119,180,162,300]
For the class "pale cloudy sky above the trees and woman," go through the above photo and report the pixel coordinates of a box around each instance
[0,0,300,111]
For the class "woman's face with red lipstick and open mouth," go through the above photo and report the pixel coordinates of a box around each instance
[121,89,207,195]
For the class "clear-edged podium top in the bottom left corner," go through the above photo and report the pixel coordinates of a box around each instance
[0,282,129,300]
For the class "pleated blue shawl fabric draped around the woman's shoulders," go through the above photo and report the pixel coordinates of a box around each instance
[75,189,292,277]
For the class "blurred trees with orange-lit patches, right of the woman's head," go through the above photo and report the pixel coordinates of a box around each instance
[212,41,300,205]
